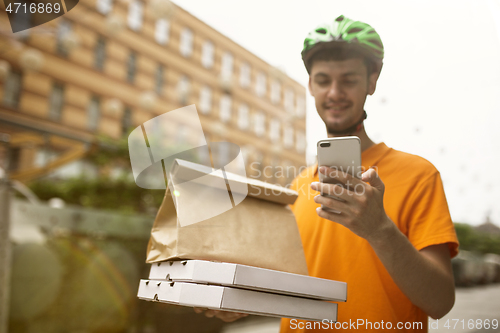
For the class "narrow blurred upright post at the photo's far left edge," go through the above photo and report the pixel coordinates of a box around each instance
[0,133,11,333]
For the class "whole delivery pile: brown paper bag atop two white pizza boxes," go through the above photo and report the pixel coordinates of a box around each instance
[138,160,347,322]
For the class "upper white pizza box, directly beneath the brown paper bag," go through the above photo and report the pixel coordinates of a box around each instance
[149,260,347,302]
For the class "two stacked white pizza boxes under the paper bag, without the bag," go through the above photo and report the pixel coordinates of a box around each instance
[138,260,347,322]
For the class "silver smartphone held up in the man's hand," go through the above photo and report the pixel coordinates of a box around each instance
[317,136,362,213]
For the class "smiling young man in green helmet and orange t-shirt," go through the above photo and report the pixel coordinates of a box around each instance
[281,16,458,332]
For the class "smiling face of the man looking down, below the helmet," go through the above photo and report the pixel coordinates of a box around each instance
[309,58,378,133]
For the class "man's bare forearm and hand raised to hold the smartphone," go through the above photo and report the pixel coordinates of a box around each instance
[311,167,455,319]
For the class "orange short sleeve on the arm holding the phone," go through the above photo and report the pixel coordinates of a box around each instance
[406,171,458,258]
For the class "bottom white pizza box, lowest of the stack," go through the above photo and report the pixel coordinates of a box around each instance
[137,280,337,322]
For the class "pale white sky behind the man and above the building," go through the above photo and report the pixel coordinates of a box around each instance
[173,0,500,226]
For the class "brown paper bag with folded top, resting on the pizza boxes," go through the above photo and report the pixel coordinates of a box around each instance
[146,160,308,275]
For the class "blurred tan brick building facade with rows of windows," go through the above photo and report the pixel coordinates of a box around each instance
[0,0,306,185]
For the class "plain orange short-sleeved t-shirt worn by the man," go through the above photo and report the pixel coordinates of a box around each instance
[281,143,458,333]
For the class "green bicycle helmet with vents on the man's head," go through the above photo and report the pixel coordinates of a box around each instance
[302,15,384,74]
